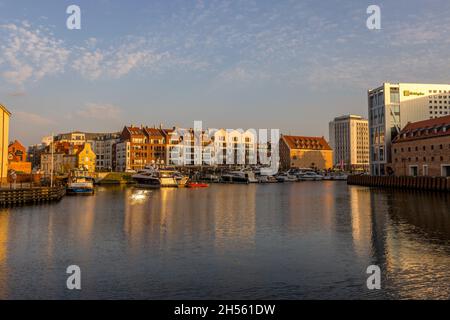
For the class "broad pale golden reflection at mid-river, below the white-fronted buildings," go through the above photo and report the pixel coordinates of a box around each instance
[211,185,257,252]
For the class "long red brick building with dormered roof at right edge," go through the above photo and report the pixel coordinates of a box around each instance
[391,116,450,177]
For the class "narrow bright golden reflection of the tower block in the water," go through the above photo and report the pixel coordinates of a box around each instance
[349,187,372,257]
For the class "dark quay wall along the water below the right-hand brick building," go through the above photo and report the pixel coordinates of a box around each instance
[347,176,450,192]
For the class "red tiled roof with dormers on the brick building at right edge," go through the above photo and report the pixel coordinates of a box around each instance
[392,116,450,143]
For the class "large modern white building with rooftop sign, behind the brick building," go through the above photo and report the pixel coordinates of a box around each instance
[367,83,450,175]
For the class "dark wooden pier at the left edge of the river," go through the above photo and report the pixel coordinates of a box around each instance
[0,186,66,206]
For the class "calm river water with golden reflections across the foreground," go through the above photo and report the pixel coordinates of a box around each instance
[0,181,450,299]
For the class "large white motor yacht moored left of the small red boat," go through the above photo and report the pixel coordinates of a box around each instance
[131,167,189,188]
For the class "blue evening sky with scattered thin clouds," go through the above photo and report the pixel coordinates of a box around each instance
[0,0,450,145]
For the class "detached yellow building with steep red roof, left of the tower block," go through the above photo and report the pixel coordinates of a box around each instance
[280,135,333,170]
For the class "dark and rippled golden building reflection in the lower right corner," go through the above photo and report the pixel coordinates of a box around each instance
[374,191,450,299]
